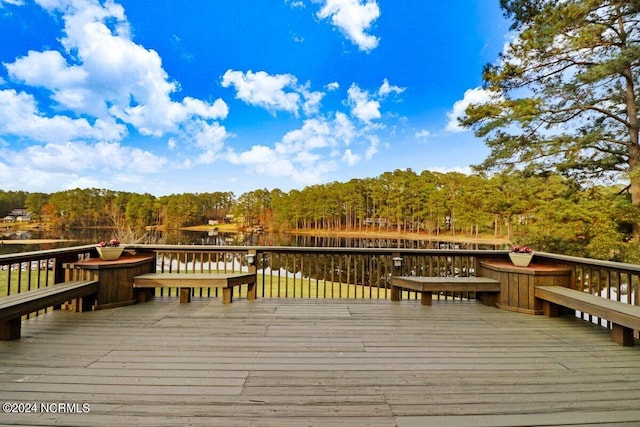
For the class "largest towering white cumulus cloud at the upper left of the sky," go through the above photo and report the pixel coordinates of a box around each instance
[4,0,228,149]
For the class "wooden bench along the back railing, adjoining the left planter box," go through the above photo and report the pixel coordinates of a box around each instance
[133,273,256,304]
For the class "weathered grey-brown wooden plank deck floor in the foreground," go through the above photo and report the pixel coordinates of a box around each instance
[0,298,640,427]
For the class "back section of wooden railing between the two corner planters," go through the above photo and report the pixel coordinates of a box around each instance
[131,245,507,299]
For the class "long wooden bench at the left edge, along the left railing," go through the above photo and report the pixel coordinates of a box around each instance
[0,280,99,340]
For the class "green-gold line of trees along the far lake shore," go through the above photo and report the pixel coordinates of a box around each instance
[0,169,640,262]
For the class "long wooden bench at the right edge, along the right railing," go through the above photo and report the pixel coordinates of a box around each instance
[535,286,640,346]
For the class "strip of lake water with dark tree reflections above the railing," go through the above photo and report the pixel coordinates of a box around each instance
[0,228,502,254]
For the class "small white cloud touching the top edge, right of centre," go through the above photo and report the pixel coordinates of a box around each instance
[317,0,380,52]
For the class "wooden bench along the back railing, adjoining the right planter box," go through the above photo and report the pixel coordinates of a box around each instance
[391,276,500,306]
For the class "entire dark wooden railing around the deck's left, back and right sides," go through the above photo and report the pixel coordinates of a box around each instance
[0,245,640,326]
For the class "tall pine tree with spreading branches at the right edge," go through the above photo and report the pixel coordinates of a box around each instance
[463,0,640,236]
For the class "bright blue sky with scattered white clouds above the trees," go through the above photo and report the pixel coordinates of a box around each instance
[0,0,508,196]
